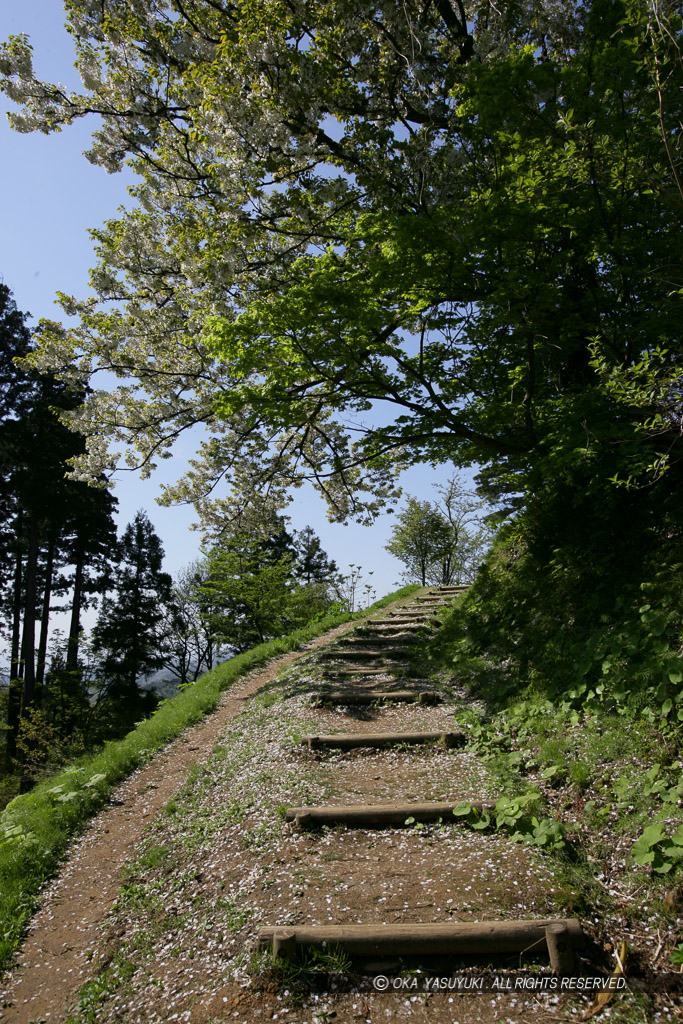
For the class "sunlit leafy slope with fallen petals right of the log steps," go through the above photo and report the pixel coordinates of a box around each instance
[421,595,683,974]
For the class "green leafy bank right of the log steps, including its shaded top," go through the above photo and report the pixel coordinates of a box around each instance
[416,586,683,972]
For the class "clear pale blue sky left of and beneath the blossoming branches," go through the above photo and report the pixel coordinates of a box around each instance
[0,0,466,597]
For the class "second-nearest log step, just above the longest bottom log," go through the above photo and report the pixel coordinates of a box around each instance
[285,800,494,828]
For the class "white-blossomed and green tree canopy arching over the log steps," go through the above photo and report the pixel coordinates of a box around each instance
[0,0,683,520]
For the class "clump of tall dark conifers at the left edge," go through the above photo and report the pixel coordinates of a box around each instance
[0,285,116,761]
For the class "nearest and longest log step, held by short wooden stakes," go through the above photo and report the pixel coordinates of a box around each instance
[258,918,586,974]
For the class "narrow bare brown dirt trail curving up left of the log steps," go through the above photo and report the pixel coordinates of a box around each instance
[0,623,357,1024]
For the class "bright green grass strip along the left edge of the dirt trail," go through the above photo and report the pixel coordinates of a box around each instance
[0,587,420,970]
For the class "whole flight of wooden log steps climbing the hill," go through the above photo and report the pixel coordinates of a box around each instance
[258,587,584,974]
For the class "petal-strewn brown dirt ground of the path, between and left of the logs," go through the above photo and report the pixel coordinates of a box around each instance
[3,593,589,1024]
